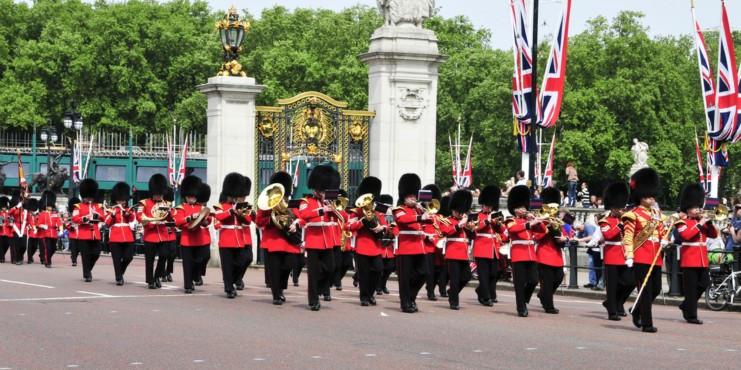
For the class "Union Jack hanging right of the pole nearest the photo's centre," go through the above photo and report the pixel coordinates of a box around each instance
[538,0,571,128]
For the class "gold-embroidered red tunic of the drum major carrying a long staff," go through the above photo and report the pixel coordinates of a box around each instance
[622,207,664,266]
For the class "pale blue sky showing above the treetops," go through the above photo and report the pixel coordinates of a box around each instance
[208,0,741,49]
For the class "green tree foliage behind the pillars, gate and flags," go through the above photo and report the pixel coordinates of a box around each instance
[0,0,741,200]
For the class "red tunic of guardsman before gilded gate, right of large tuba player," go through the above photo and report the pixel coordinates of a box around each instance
[298,196,340,249]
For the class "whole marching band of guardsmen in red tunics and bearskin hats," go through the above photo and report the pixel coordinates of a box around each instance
[0,165,718,333]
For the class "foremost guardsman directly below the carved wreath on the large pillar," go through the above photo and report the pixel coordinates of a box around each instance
[393,173,432,313]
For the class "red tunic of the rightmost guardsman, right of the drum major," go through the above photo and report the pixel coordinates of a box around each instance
[677,219,718,268]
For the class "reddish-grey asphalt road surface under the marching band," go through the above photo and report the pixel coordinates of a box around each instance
[0,255,741,369]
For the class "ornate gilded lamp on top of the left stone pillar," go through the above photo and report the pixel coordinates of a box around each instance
[216,5,250,77]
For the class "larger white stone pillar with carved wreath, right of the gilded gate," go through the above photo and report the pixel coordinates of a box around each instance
[360,25,446,199]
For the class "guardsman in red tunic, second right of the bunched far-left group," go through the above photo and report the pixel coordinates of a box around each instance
[105,182,136,286]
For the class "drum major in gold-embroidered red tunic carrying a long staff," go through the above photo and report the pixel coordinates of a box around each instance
[622,168,666,333]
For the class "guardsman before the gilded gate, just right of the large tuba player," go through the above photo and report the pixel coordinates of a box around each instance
[298,165,340,311]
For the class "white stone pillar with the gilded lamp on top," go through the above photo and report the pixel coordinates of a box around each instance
[197,76,265,265]
